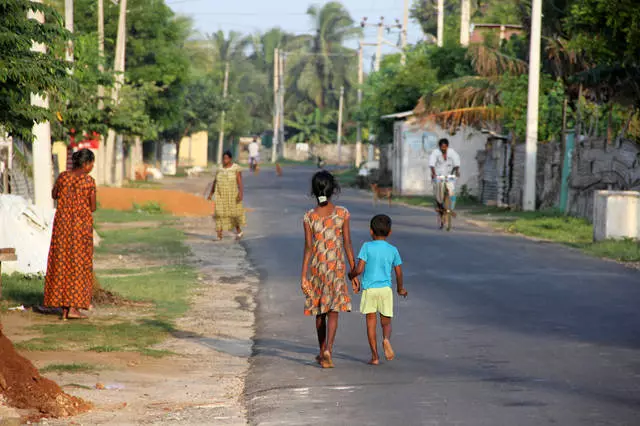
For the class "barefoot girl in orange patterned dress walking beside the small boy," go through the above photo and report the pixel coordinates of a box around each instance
[301,170,358,368]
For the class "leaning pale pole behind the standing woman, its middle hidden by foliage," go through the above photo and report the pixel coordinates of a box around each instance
[104,0,127,184]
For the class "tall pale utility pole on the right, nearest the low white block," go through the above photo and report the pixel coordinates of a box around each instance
[522,0,542,211]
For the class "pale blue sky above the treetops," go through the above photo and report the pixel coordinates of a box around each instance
[166,0,422,68]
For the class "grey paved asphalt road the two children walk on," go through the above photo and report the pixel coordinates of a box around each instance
[244,168,640,426]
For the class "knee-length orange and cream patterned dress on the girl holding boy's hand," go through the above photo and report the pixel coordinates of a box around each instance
[304,207,351,315]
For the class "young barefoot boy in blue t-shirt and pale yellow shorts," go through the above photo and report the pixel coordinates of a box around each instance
[349,214,408,365]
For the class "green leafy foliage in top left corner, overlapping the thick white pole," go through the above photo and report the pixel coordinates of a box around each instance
[0,0,71,140]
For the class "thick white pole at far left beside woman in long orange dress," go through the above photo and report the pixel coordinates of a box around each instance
[27,0,53,210]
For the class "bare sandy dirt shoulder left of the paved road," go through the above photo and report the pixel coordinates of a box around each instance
[0,183,259,425]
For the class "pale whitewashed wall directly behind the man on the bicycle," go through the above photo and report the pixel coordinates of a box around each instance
[390,121,487,195]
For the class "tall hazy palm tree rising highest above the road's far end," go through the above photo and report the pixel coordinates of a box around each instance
[287,2,361,110]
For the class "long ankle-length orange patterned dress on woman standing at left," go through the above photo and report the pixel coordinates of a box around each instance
[44,172,96,309]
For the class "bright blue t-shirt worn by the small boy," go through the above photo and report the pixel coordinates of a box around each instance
[358,240,402,290]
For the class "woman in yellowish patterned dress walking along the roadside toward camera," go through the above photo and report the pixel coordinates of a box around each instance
[207,151,246,240]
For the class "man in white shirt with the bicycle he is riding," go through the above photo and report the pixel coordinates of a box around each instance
[429,138,460,224]
